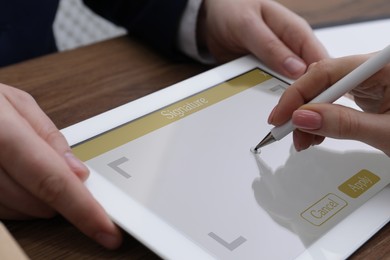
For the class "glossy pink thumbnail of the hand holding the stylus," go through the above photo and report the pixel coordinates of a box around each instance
[292,110,322,130]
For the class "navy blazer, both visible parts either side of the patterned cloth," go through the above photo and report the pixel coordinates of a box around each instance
[0,0,187,67]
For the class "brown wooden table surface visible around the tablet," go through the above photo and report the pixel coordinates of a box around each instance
[0,0,390,259]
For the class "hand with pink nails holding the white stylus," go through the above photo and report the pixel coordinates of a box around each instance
[268,51,390,156]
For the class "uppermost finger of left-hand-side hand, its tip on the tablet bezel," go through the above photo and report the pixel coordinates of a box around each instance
[0,84,89,181]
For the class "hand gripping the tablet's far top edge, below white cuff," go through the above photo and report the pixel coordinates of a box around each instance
[198,0,327,78]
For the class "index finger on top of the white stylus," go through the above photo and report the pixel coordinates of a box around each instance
[268,56,366,126]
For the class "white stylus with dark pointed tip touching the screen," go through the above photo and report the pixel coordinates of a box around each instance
[254,45,390,151]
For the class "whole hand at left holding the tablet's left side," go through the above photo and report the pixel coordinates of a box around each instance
[0,84,121,248]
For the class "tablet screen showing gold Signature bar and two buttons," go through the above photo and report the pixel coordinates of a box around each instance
[73,68,390,259]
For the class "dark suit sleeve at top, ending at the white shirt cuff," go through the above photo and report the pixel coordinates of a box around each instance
[83,0,187,56]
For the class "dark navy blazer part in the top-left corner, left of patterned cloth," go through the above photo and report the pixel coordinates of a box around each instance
[0,0,59,66]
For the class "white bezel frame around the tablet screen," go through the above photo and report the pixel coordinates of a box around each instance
[61,55,390,259]
